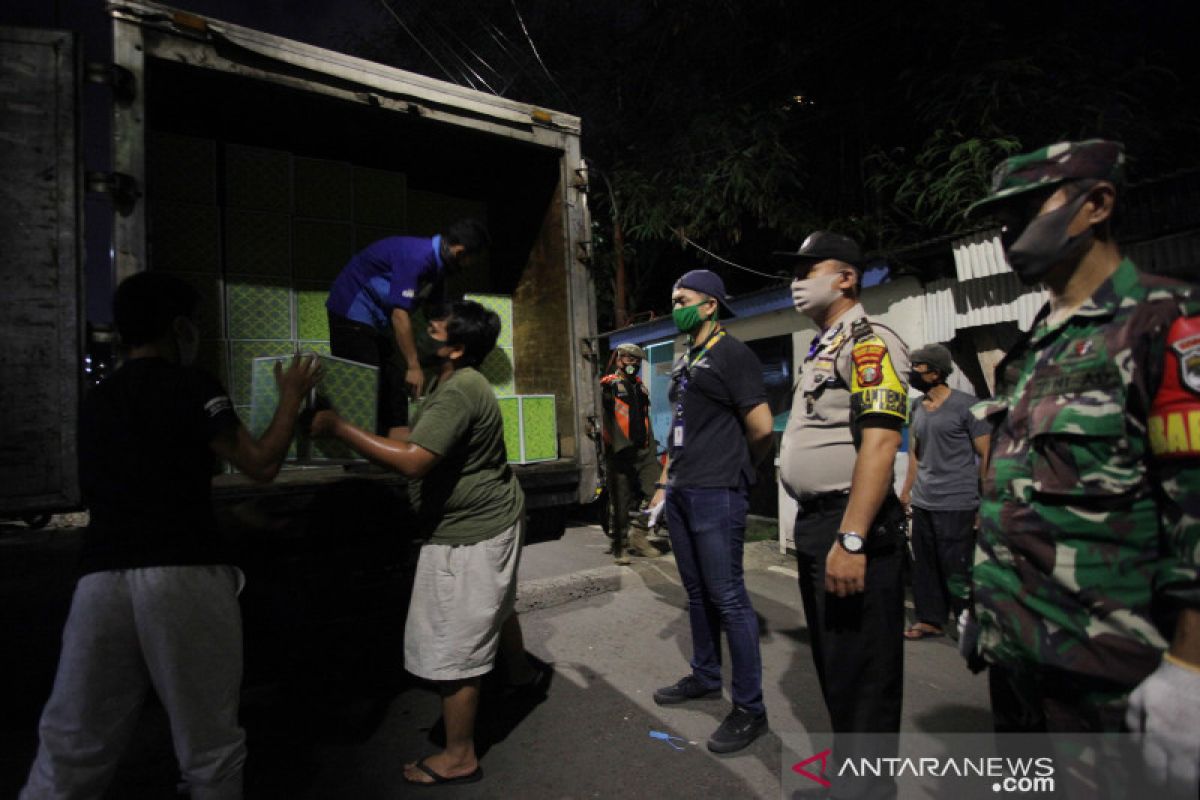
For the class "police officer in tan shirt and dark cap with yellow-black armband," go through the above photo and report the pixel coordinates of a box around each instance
[778,231,908,794]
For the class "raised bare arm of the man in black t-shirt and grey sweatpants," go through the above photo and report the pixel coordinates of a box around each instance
[209,356,320,483]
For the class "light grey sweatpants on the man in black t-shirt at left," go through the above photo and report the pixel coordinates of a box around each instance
[20,566,246,800]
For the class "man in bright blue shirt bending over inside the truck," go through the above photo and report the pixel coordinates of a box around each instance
[325,219,490,435]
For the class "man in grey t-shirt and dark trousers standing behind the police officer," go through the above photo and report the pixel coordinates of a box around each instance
[900,344,989,640]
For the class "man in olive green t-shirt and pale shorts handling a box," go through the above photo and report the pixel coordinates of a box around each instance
[312,301,545,784]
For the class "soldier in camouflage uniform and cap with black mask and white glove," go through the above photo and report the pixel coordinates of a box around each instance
[964,140,1200,796]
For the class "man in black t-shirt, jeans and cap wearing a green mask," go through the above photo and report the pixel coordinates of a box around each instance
[652,270,773,753]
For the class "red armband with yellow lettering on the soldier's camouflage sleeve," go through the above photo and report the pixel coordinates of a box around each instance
[1148,315,1200,458]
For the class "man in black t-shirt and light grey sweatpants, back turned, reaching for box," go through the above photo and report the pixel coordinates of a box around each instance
[20,272,318,800]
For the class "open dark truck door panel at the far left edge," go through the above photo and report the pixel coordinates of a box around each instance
[0,26,83,516]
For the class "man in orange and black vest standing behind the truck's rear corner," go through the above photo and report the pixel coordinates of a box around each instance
[600,343,662,564]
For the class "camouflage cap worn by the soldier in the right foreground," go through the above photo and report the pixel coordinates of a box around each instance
[966,139,1124,219]
